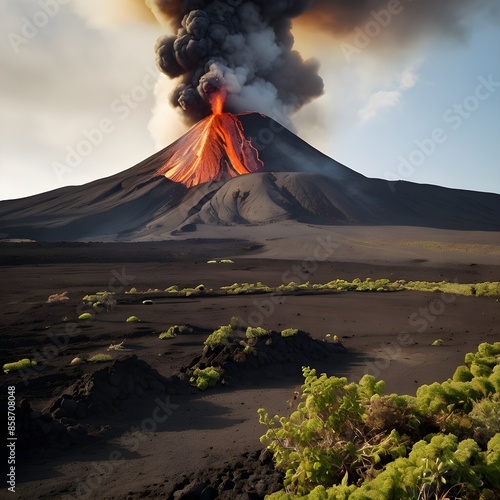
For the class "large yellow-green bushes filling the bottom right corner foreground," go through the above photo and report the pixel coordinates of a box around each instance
[259,342,500,500]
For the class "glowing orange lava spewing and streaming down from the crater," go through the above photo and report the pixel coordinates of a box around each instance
[156,92,264,187]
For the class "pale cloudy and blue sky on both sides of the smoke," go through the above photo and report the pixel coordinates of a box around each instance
[0,0,500,200]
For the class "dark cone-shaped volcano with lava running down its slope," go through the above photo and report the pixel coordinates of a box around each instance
[0,112,500,241]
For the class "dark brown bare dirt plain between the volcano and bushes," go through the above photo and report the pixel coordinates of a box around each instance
[0,239,500,499]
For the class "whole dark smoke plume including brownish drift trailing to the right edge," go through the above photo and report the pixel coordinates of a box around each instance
[150,0,498,122]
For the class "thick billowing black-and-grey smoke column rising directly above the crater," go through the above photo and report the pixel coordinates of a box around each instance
[155,0,323,122]
